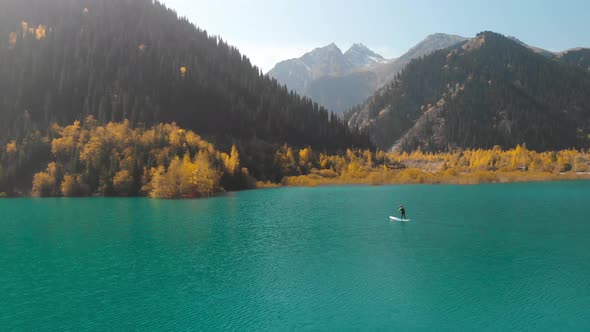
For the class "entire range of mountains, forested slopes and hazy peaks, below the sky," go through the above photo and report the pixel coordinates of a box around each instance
[0,0,590,192]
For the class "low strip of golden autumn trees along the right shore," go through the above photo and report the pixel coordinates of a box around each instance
[275,145,590,186]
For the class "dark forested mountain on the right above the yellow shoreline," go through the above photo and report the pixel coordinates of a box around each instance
[347,32,590,151]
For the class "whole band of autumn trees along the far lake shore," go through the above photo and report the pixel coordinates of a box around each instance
[0,116,590,198]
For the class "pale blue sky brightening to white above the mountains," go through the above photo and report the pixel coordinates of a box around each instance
[162,0,590,72]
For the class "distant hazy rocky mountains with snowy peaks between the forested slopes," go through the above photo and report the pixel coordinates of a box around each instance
[268,33,466,113]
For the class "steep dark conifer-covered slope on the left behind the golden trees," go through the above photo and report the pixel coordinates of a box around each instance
[0,0,371,192]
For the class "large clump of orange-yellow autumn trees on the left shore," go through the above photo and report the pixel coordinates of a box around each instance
[33,117,245,198]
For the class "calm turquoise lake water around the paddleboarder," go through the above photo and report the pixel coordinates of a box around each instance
[0,182,590,331]
